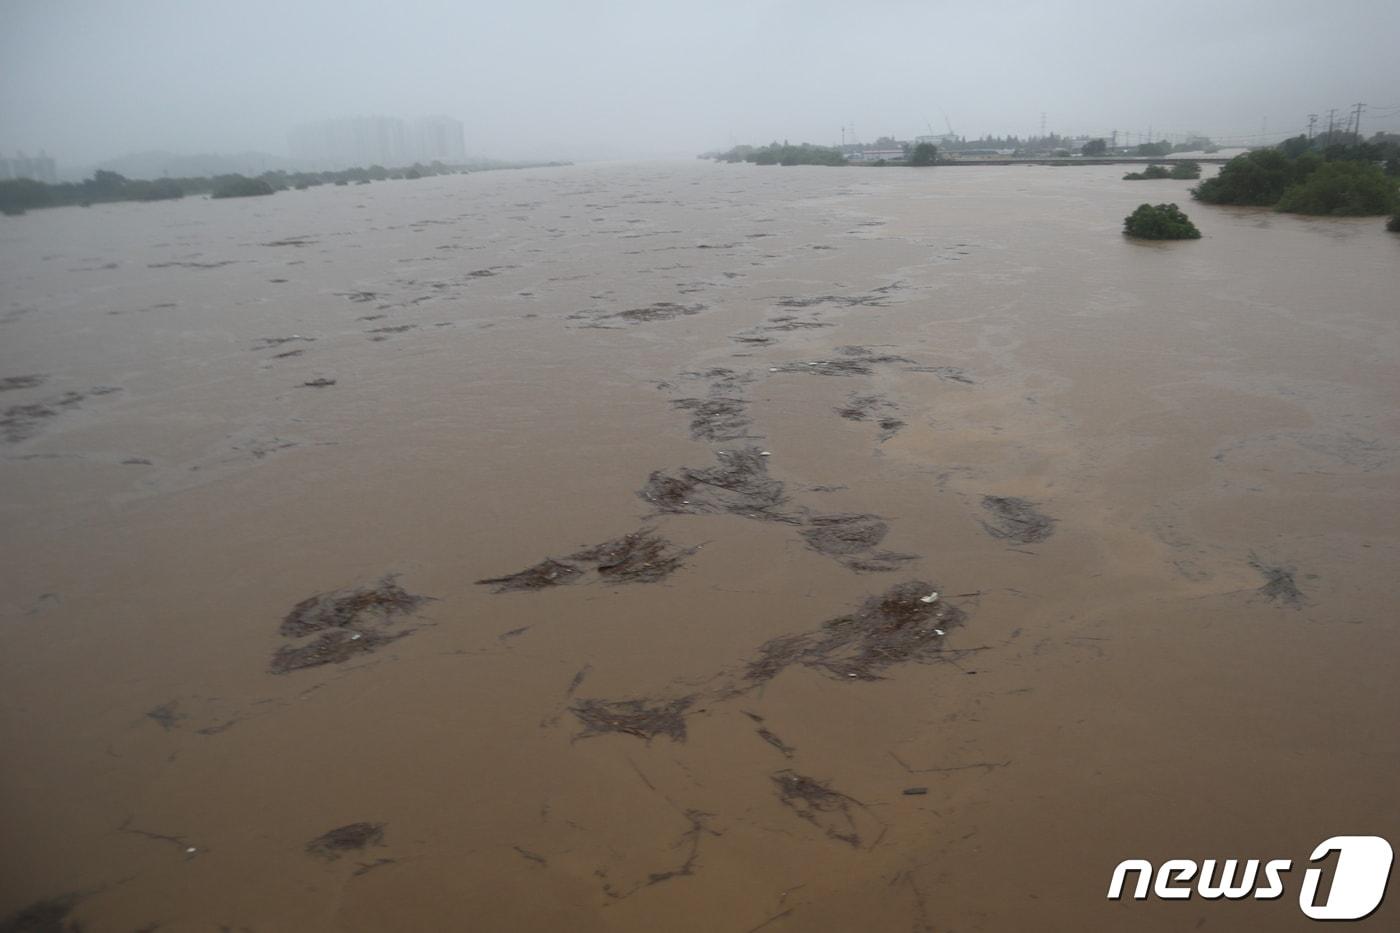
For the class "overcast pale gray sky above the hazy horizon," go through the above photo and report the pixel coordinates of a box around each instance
[8,0,1400,165]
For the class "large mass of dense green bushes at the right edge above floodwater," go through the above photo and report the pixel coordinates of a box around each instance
[1191,133,1400,217]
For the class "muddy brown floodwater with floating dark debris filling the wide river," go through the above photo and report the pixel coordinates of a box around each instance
[0,163,1400,933]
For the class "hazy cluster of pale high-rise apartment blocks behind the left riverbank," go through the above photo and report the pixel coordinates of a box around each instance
[288,116,466,168]
